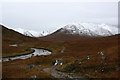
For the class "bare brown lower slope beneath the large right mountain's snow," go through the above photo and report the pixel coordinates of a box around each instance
[39,29,100,41]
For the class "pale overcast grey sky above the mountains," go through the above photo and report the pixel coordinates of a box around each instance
[2,2,118,31]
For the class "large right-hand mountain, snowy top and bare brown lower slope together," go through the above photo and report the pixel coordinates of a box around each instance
[40,23,118,41]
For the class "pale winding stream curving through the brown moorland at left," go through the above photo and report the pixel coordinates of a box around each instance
[0,48,52,62]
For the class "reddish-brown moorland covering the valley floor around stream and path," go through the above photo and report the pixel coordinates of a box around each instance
[2,27,120,78]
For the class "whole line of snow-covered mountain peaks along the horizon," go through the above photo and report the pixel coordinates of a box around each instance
[10,23,118,37]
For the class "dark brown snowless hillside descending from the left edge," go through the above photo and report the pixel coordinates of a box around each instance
[1,25,37,43]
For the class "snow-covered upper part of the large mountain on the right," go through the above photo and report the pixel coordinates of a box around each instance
[58,23,118,36]
